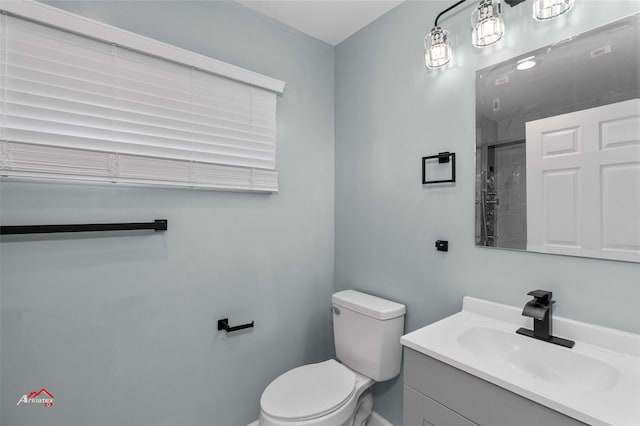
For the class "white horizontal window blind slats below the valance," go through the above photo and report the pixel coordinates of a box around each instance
[0,15,278,191]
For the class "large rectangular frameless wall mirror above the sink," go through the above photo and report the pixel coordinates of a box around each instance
[475,14,640,262]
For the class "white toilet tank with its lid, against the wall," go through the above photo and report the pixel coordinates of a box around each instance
[331,290,406,382]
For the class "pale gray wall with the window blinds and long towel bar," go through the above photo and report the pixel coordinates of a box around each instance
[0,1,334,426]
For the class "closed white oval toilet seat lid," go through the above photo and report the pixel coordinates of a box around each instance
[260,359,356,421]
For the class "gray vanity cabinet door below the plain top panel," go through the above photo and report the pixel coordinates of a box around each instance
[403,385,478,426]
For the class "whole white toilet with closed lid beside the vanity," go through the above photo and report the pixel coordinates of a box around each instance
[259,290,405,426]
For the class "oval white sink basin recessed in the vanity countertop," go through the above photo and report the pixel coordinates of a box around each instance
[458,327,620,391]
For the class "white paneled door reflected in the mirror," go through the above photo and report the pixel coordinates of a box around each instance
[526,99,640,261]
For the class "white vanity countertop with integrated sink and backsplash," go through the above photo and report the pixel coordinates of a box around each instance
[401,297,640,426]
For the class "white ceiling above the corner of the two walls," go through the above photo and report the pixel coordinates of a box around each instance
[236,0,404,46]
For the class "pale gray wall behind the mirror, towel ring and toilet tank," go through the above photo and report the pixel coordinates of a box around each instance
[335,1,640,425]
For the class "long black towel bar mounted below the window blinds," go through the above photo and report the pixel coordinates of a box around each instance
[0,219,167,235]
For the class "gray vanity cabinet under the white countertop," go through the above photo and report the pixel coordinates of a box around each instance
[403,347,585,426]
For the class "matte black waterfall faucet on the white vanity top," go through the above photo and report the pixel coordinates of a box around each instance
[516,290,575,348]
